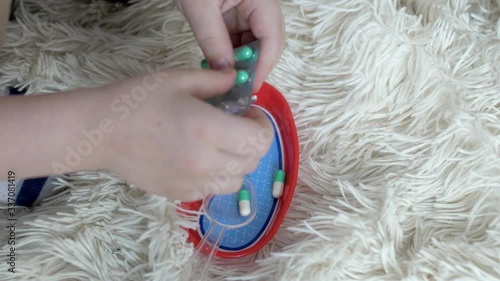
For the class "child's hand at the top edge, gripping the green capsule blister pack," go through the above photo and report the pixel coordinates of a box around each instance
[175,0,285,90]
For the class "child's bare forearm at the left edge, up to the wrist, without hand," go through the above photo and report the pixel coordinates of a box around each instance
[0,89,110,180]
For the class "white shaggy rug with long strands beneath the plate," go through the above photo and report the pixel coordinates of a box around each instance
[0,0,500,281]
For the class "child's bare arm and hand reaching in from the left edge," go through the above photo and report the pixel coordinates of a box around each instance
[0,70,274,201]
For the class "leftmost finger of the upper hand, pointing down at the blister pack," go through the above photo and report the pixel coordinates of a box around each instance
[179,0,234,69]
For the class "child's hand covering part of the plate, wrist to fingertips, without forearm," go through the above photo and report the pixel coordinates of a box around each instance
[102,70,273,201]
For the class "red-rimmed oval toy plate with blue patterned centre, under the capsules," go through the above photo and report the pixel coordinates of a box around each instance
[180,83,299,258]
